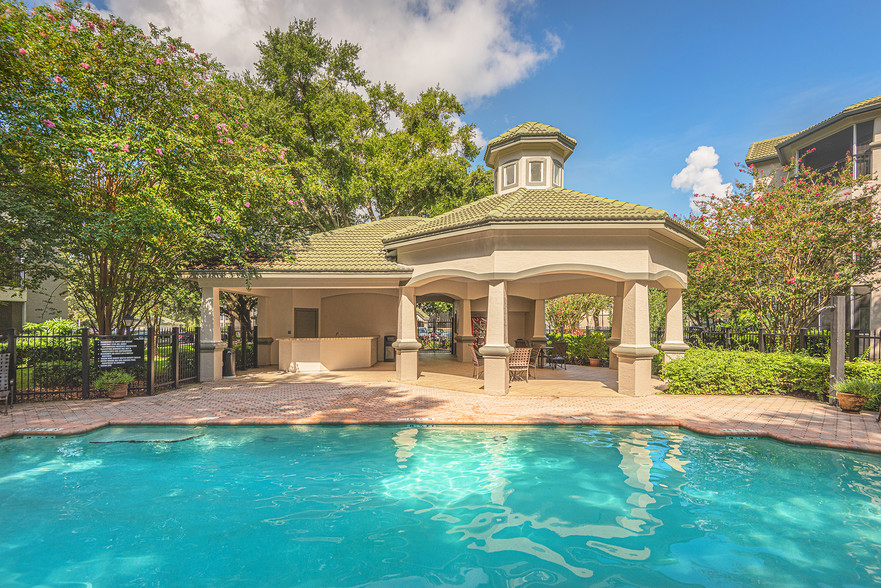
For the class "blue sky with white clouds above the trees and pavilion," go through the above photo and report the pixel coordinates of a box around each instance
[99,0,881,214]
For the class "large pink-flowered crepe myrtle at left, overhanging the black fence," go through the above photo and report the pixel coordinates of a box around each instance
[0,2,297,333]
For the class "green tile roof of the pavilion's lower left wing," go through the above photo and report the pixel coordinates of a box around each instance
[244,216,426,273]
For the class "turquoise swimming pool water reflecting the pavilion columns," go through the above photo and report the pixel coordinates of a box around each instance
[0,426,881,587]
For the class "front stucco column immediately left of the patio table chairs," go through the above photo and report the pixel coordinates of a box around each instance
[480,280,513,396]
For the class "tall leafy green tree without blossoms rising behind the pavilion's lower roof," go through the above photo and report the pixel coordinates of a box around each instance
[248,19,492,231]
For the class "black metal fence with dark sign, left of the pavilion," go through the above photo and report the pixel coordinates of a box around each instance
[0,327,200,403]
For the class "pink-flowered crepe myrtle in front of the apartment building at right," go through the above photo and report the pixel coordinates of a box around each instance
[687,158,881,347]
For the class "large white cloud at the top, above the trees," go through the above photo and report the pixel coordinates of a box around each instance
[107,0,562,100]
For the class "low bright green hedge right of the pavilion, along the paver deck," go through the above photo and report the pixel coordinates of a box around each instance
[661,348,829,398]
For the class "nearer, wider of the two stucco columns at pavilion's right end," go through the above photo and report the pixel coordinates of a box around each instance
[612,281,658,396]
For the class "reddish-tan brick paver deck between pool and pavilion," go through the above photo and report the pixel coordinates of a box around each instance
[0,372,881,453]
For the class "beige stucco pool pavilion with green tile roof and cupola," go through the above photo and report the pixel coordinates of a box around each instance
[187,123,704,396]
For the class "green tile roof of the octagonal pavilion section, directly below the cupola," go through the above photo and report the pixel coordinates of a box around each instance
[383,188,691,244]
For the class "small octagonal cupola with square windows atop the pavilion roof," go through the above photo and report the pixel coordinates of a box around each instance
[483,122,576,194]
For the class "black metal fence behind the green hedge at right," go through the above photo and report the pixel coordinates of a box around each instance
[686,327,881,361]
